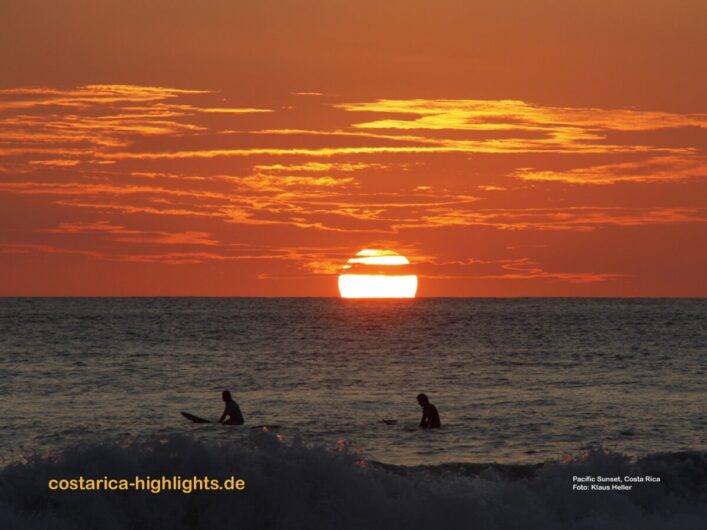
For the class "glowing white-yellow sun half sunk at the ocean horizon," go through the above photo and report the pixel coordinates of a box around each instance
[339,249,417,298]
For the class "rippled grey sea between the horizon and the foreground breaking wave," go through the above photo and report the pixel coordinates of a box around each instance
[0,298,707,465]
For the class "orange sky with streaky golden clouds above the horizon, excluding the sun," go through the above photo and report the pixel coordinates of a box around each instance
[0,0,707,296]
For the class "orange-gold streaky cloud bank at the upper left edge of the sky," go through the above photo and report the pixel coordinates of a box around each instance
[0,85,272,159]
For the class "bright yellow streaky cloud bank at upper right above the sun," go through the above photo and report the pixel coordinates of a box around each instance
[337,99,707,153]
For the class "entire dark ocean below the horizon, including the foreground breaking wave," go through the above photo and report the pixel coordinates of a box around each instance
[0,298,707,529]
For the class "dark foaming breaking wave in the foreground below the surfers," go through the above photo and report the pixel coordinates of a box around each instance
[0,433,707,530]
